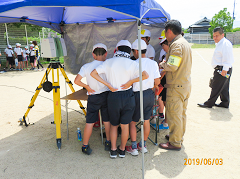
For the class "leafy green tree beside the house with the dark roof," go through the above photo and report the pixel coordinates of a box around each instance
[208,8,233,37]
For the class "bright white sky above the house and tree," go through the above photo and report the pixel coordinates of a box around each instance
[155,0,240,29]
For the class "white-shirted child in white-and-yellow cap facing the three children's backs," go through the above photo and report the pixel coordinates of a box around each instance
[141,29,155,60]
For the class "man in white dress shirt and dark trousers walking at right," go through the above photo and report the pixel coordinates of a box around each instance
[198,27,234,108]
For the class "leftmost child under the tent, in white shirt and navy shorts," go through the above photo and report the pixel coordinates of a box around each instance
[74,43,111,155]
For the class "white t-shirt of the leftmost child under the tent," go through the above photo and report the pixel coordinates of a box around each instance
[78,60,109,95]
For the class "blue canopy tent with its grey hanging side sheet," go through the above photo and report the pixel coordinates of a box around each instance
[0,0,170,177]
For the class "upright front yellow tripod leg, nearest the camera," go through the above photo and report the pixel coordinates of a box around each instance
[52,68,61,150]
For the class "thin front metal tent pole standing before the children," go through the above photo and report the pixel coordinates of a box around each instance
[137,19,145,178]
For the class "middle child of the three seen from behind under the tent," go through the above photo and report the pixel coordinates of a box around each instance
[91,40,148,158]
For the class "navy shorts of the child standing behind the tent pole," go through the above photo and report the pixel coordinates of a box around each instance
[132,89,155,122]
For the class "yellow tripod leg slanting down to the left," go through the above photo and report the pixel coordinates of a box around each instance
[20,68,51,126]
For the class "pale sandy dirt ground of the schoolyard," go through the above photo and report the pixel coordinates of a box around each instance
[0,48,240,179]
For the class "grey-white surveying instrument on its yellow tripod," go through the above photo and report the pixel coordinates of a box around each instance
[20,35,86,150]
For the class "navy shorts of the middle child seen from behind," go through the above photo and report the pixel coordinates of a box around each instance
[107,88,135,126]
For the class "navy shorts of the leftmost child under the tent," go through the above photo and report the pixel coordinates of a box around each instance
[86,91,109,123]
